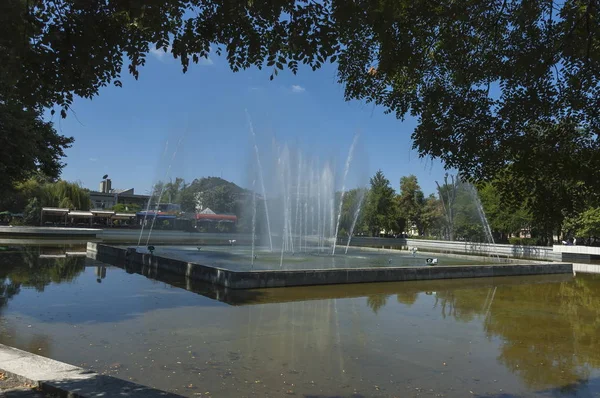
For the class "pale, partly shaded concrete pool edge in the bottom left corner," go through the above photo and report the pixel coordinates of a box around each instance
[0,344,181,398]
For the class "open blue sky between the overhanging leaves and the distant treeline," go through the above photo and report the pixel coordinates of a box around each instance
[53,47,444,194]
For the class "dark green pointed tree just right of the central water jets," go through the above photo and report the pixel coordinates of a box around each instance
[365,170,397,236]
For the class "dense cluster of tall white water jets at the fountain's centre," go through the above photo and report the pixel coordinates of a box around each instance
[251,134,362,260]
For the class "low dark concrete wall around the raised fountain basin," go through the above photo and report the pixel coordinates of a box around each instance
[87,242,573,289]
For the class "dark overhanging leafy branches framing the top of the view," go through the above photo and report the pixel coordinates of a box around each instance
[0,0,600,191]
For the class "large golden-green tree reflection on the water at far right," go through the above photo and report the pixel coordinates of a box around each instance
[438,276,600,388]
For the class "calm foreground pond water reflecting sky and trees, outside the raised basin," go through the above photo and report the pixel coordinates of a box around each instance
[0,244,600,397]
